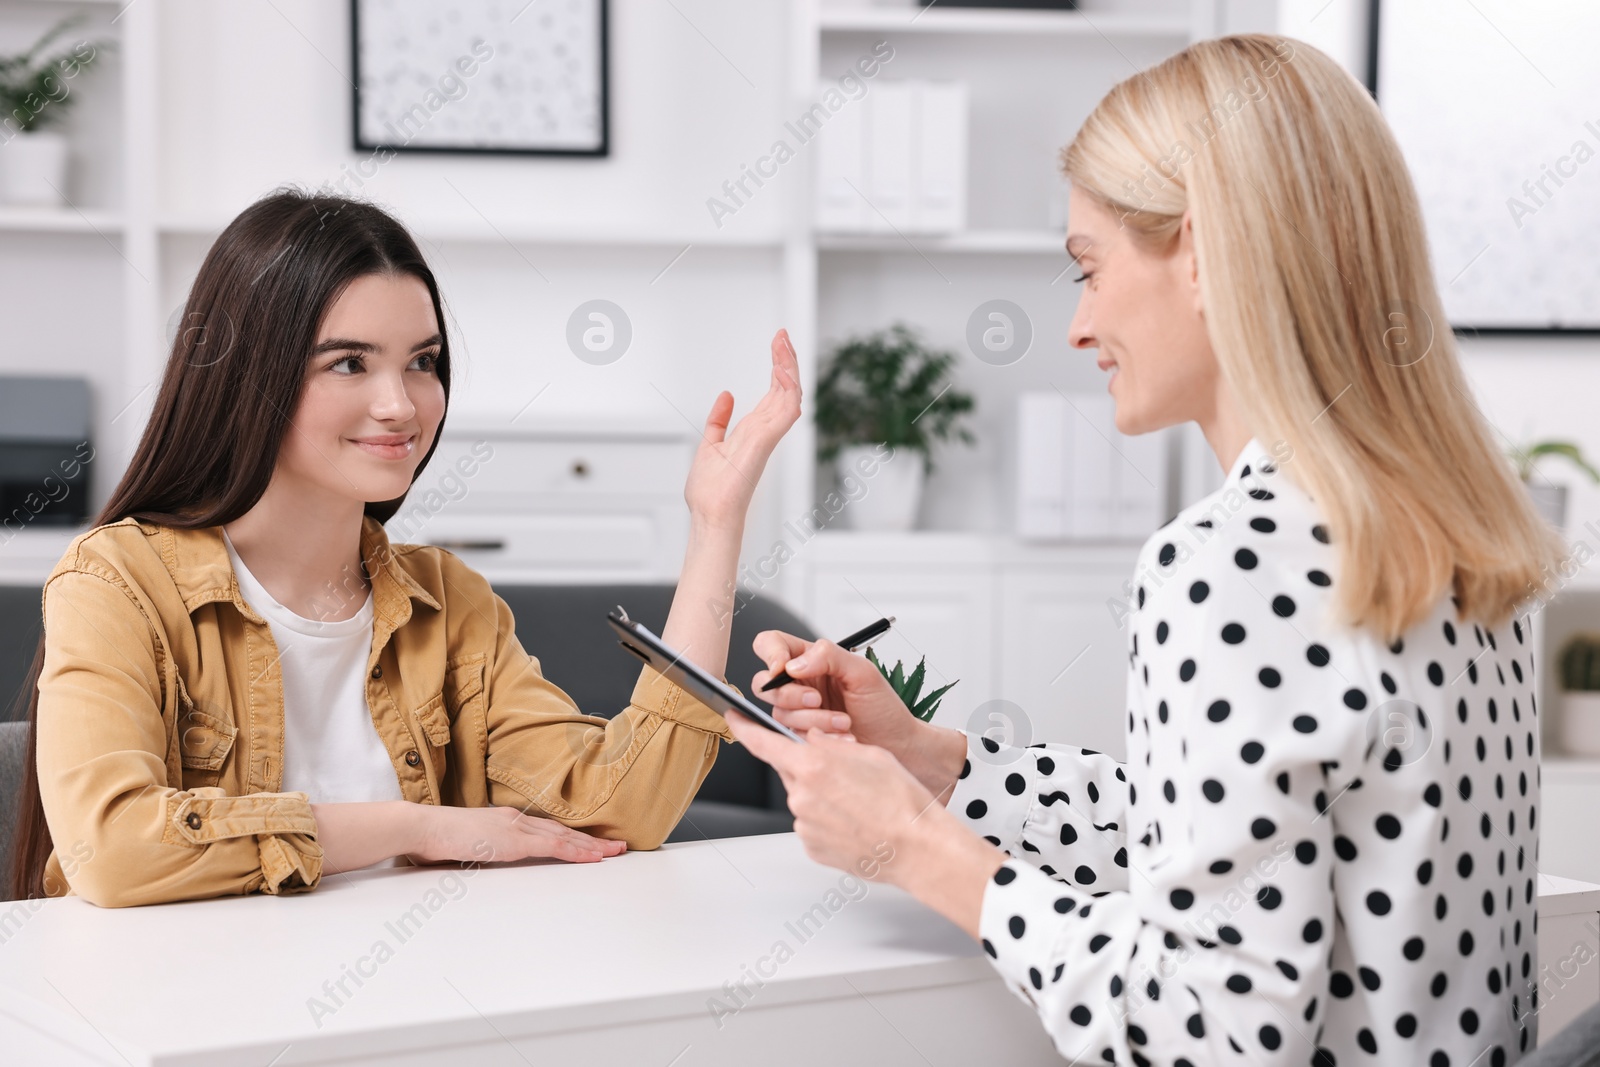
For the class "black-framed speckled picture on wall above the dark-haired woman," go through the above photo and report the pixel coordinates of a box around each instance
[350,0,610,157]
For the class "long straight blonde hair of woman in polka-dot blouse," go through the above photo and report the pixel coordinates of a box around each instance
[1061,34,1566,641]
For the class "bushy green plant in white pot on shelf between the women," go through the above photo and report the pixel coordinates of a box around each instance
[816,323,976,530]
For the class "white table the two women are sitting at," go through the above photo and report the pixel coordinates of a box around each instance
[0,833,1600,1067]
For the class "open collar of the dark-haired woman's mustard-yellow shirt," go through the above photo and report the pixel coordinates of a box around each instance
[160,515,440,625]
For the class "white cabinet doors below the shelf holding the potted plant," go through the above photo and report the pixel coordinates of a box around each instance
[795,531,1138,758]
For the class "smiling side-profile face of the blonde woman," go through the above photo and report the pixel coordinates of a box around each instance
[1067,186,1221,434]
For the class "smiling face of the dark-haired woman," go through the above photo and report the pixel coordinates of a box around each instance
[275,274,445,504]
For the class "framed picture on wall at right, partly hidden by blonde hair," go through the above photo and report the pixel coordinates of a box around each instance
[1368,0,1600,336]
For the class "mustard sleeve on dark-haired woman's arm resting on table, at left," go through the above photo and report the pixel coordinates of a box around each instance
[35,569,322,907]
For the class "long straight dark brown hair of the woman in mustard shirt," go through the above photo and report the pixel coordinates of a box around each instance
[8,189,450,899]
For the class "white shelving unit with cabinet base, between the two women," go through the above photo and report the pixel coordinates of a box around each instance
[779,0,1219,753]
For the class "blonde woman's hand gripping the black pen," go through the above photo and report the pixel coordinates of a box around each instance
[750,630,966,801]
